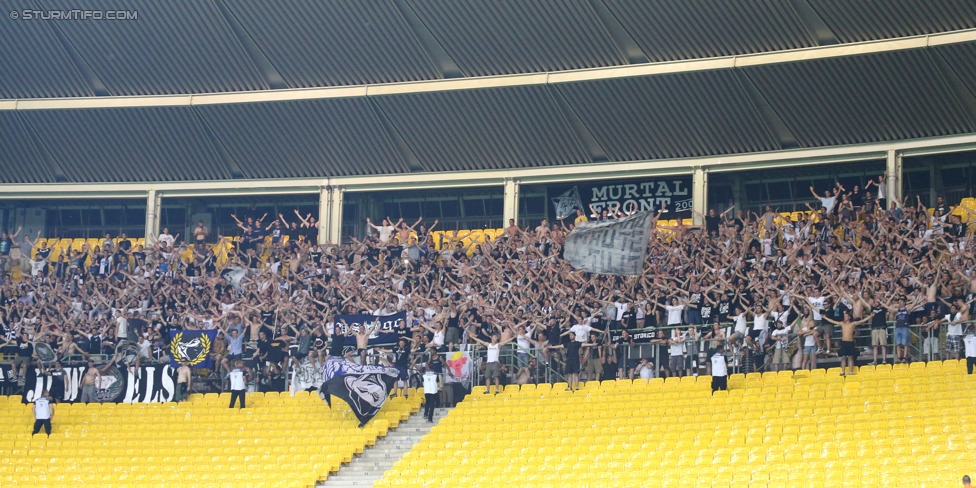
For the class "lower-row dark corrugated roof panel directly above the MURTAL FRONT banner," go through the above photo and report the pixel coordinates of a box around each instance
[558,71,780,161]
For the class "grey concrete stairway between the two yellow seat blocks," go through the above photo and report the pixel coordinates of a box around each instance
[318,408,448,488]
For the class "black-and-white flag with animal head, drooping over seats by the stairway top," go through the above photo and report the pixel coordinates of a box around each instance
[319,356,399,427]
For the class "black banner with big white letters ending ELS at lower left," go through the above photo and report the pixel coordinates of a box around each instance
[23,363,176,403]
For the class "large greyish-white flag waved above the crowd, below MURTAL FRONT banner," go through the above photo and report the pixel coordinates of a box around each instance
[565,212,654,275]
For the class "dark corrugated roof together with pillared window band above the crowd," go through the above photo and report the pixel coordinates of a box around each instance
[0,0,976,242]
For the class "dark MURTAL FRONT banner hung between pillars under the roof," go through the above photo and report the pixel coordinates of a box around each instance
[548,175,692,220]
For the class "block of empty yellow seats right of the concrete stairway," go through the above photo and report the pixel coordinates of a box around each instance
[376,361,976,488]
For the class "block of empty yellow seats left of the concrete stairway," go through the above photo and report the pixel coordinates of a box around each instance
[0,392,423,488]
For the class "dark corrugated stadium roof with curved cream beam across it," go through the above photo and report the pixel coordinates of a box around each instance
[0,0,976,183]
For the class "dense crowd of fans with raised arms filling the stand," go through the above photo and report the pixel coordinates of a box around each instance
[0,173,976,402]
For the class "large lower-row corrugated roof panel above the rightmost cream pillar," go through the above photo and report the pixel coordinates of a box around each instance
[744,50,976,147]
